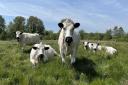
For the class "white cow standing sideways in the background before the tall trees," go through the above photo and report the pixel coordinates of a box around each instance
[16,31,40,49]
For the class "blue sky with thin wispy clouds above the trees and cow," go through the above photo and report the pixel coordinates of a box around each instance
[0,0,128,32]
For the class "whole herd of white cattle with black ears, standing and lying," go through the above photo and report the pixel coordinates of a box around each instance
[16,18,117,66]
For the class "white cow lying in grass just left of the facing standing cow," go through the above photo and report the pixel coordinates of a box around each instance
[30,43,58,66]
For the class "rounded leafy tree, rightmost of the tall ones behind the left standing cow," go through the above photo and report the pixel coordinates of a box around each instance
[27,16,44,34]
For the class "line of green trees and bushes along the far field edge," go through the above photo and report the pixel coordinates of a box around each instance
[0,15,128,41]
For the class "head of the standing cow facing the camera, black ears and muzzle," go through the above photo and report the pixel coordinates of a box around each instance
[58,19,80,45]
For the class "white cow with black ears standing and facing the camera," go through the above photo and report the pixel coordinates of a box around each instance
[58,19,80,64]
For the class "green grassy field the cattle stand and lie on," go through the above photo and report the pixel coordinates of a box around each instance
[0,41,128,85]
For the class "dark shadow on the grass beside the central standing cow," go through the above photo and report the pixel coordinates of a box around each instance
[73,58,100,81]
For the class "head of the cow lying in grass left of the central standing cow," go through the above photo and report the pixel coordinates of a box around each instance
[32,43,49,61]
